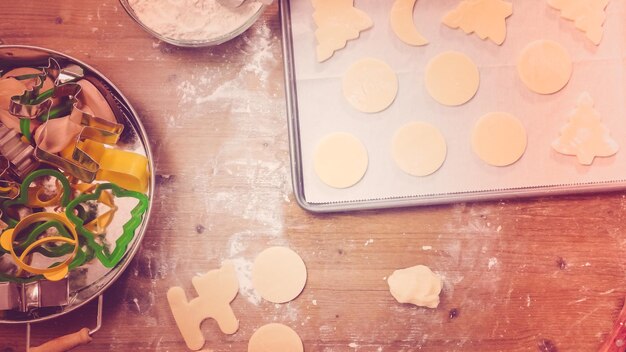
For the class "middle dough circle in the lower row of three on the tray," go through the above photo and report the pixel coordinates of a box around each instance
[391,122,447,176]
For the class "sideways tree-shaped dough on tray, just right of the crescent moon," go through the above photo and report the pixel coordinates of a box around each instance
[442,0,513,45]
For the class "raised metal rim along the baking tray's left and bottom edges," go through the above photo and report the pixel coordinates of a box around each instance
[279,0,626,213]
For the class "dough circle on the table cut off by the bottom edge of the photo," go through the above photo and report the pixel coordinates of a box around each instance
[248,323,304,352]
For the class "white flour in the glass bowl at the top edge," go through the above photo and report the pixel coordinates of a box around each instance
[128,0,261,40]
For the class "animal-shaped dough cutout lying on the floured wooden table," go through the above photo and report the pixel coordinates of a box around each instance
[167,261,239,351]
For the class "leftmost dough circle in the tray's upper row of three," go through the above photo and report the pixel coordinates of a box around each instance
[343,58,398,113]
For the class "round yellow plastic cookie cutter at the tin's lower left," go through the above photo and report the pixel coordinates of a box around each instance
[0,213,79,281]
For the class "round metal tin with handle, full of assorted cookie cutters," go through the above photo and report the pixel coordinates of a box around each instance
[0,45,154,351]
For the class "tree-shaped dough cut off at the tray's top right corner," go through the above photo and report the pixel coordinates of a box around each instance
[548,0,609,45]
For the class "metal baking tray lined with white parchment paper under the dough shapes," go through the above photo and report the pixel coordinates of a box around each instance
[281,0,626,212]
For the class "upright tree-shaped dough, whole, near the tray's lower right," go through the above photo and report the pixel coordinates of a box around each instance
[552,92,619,165]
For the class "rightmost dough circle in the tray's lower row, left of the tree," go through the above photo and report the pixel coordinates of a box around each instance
[472,112,527,166]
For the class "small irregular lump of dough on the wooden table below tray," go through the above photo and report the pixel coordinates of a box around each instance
[387,265,443,308]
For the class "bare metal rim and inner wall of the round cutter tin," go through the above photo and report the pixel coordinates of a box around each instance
[0,45,154,324]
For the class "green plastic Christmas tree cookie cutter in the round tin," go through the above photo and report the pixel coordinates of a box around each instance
[65,183,149,268]
